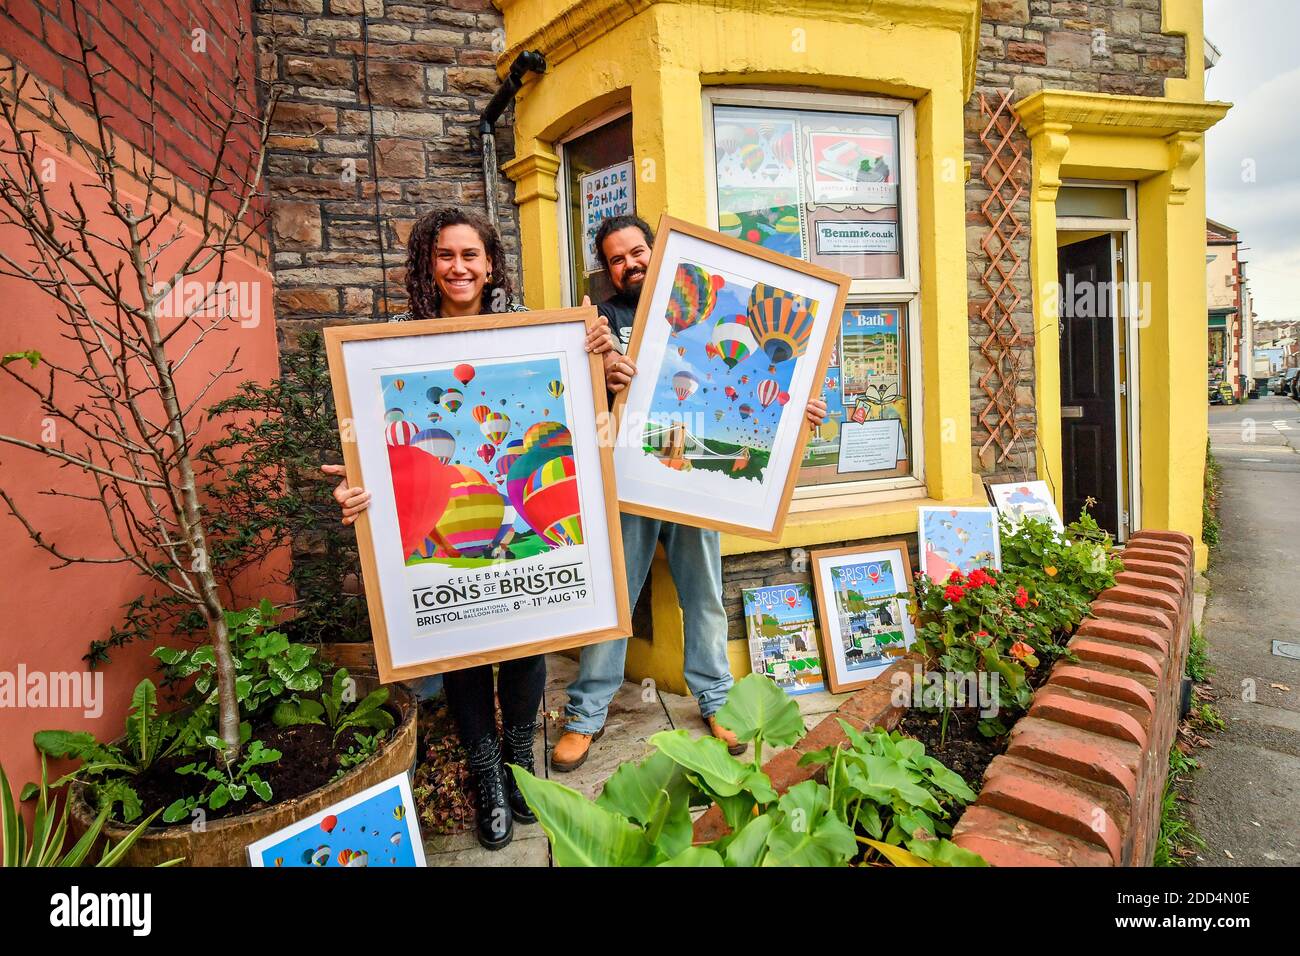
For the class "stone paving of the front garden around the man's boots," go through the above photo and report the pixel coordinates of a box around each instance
[424,654,850,866]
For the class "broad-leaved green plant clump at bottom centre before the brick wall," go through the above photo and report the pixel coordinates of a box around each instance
[512,674,978,866]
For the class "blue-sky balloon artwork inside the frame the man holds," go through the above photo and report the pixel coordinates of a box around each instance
[644,261,816,481]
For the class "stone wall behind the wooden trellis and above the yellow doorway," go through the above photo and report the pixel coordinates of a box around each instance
[966,0,1187,480]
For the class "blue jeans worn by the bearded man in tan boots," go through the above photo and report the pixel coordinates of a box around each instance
[564,515,732,734]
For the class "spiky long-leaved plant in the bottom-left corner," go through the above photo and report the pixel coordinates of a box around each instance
[0,754,181,869]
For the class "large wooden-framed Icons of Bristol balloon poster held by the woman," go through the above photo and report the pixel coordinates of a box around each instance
[325,307,632,683]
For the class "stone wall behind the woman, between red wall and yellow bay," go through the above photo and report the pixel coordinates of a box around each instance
[256,0,519,342]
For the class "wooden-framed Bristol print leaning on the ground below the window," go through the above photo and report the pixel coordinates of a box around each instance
[811,541,917,693]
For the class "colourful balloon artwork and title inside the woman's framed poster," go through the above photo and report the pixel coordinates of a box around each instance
[380,358,586,623]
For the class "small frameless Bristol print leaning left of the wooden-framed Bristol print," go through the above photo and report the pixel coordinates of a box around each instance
[741,584,823,695]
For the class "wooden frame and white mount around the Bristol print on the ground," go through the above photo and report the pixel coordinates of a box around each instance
[809,540,917,693]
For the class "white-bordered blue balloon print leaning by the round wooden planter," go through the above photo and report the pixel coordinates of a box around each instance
[248,774,425,868]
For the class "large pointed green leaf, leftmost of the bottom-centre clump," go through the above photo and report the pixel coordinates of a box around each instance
[511,765,655,866]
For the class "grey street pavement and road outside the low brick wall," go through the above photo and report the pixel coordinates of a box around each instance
[1188,395,1300,866]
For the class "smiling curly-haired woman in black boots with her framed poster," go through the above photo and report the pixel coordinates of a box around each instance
[325,209,632,849]
